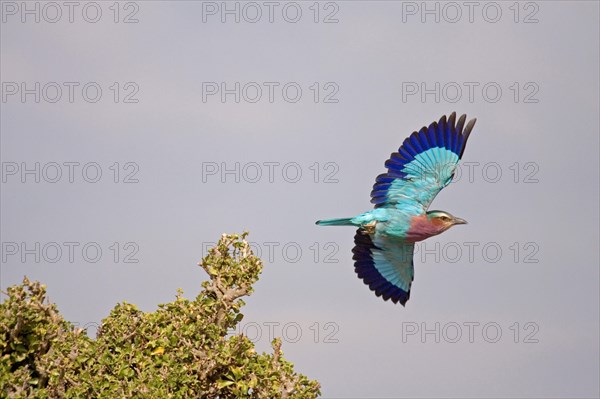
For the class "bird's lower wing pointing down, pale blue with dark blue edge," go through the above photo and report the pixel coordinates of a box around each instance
[352,229,414,306]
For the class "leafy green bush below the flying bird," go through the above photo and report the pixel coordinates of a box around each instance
[0,234,320,399]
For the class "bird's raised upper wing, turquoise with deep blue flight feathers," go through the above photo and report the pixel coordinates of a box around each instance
[371,112,476,213]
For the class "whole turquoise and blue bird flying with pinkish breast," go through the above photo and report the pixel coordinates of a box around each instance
[317,112,476,306]
